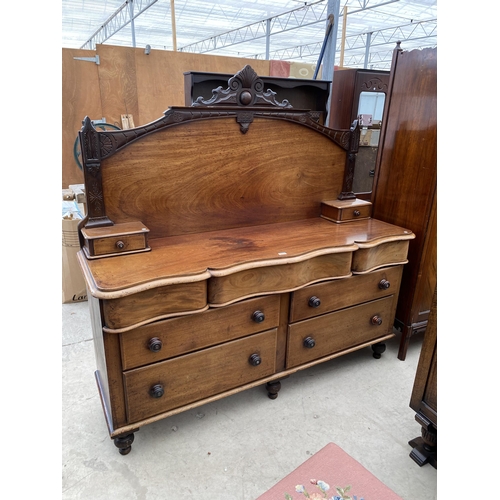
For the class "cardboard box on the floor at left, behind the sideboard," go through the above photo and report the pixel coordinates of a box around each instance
[62,200,87,304]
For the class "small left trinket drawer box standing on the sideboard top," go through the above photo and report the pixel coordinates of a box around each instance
[81,222,150,259]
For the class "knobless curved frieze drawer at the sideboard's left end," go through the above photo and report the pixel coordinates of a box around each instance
[102,281,207,333]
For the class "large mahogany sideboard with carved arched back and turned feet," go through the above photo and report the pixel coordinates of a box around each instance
[79,66,414,454]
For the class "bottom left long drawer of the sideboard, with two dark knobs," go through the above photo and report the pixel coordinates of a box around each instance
[123,328,277,423]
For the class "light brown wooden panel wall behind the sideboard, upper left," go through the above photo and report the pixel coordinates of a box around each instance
[62,45,269,189]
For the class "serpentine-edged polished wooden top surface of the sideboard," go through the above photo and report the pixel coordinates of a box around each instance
[78,217,414,298]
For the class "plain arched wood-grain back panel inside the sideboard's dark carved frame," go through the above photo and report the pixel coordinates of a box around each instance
[101,117,346,238]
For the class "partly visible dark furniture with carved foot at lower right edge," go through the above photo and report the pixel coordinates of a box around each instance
[409,289,437,469]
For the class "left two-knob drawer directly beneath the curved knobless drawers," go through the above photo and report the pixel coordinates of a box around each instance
[120,295,280,370]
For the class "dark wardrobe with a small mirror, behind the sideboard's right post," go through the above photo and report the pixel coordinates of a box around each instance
[328,68,389,200]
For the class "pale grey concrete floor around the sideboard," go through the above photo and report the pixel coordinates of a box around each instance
[62,302,437,500]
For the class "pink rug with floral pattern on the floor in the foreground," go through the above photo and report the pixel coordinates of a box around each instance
[257,443,402,500]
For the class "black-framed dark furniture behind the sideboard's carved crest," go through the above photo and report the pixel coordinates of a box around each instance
[184,71,330,123]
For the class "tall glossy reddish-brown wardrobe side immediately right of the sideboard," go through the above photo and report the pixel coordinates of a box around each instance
[372,44,437,360]
